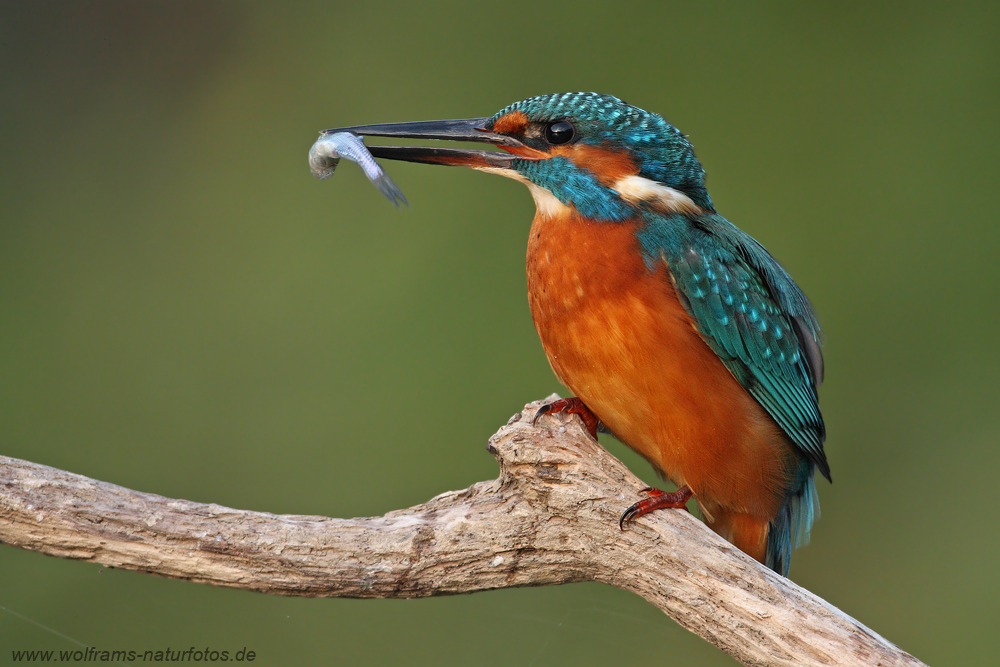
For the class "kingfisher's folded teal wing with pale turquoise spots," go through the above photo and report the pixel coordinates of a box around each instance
[639,213,830,479]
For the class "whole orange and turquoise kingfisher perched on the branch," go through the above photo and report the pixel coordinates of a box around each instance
[325,93,832,576]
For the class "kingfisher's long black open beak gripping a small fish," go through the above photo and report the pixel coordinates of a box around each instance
[320,118,524,169]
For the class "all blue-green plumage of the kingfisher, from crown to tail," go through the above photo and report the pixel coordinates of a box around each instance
[487,93,830,574]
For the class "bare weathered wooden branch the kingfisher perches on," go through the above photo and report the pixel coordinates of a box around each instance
[0,397,923,667]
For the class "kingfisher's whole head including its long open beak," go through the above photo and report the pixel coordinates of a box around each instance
[326,93,713,222]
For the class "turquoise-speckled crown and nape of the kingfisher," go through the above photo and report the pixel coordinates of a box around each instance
[486,93,714,211]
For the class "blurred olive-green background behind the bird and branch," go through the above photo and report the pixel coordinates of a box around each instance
[0,0,1000,665]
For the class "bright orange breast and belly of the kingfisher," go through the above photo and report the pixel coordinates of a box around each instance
[528,213,794,528]
